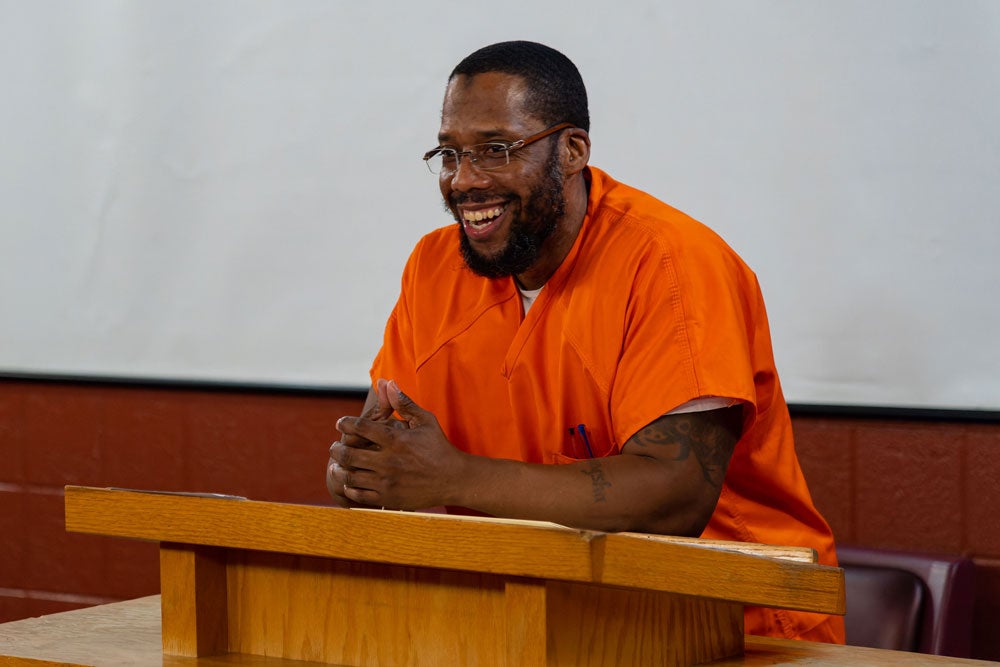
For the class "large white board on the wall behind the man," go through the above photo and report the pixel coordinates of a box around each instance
[0,0,1000,410]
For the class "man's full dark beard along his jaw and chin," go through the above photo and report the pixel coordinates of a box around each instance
[458,144,566,278]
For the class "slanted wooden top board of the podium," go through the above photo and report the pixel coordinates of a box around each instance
[65,486,844,614]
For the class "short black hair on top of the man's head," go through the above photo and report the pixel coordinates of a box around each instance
[448,41,590,132]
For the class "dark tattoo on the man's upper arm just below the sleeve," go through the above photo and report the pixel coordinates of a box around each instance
[632,408,739,488]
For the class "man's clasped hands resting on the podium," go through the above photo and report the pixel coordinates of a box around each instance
[326,379,468,510]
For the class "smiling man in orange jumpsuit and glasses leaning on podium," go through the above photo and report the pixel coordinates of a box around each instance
[327,42,843,642]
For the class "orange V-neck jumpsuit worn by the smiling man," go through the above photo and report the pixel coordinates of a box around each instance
[371,167,843,642]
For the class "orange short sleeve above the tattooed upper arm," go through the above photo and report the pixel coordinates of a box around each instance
[611,236,756,443]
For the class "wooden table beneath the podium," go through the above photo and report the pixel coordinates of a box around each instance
[0,595,1000,667]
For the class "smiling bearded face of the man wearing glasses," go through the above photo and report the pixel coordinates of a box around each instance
[438,73,565,278]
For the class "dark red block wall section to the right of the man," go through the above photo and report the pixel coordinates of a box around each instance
[793,417,1000,660]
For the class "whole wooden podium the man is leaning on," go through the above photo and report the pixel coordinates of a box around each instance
[60,487,844,667]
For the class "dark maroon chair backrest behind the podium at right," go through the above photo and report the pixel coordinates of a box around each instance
[837,546,975,658]
